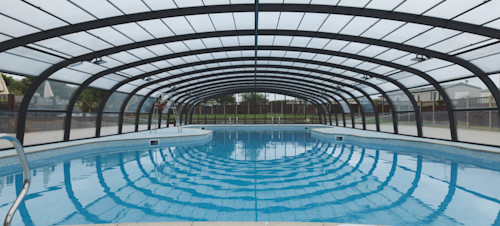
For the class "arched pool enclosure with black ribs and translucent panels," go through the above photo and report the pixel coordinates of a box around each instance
[0,0,500,147]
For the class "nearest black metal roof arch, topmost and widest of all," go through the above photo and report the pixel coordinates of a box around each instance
[0,4,500,52]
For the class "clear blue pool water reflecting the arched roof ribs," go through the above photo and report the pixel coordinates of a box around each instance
[0,129,500,225]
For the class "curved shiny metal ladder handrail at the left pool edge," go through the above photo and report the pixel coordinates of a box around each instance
[0,133,31,226]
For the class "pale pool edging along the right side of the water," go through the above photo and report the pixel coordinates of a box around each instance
[311,126,500,154]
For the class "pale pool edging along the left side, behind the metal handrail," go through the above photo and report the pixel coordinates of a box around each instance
[0,127,212,159]
